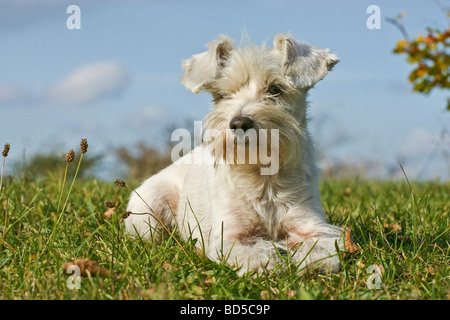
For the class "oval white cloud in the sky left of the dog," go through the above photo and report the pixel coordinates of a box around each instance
[46,61,129,105]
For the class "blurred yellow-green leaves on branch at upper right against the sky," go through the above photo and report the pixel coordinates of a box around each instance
[389,12,450,111]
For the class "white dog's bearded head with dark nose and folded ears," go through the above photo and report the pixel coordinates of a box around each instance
[181,34,339,174]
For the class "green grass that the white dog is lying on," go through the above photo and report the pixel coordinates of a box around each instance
[0,162,450,300]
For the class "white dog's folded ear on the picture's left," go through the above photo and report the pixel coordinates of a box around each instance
[181,35,235,93]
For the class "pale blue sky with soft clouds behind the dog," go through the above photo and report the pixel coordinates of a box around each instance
[0,0,450,179]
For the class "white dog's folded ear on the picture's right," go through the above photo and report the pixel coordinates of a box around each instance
[273,34,339,88]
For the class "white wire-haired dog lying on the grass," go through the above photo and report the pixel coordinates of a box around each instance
[125,34,344,274]
